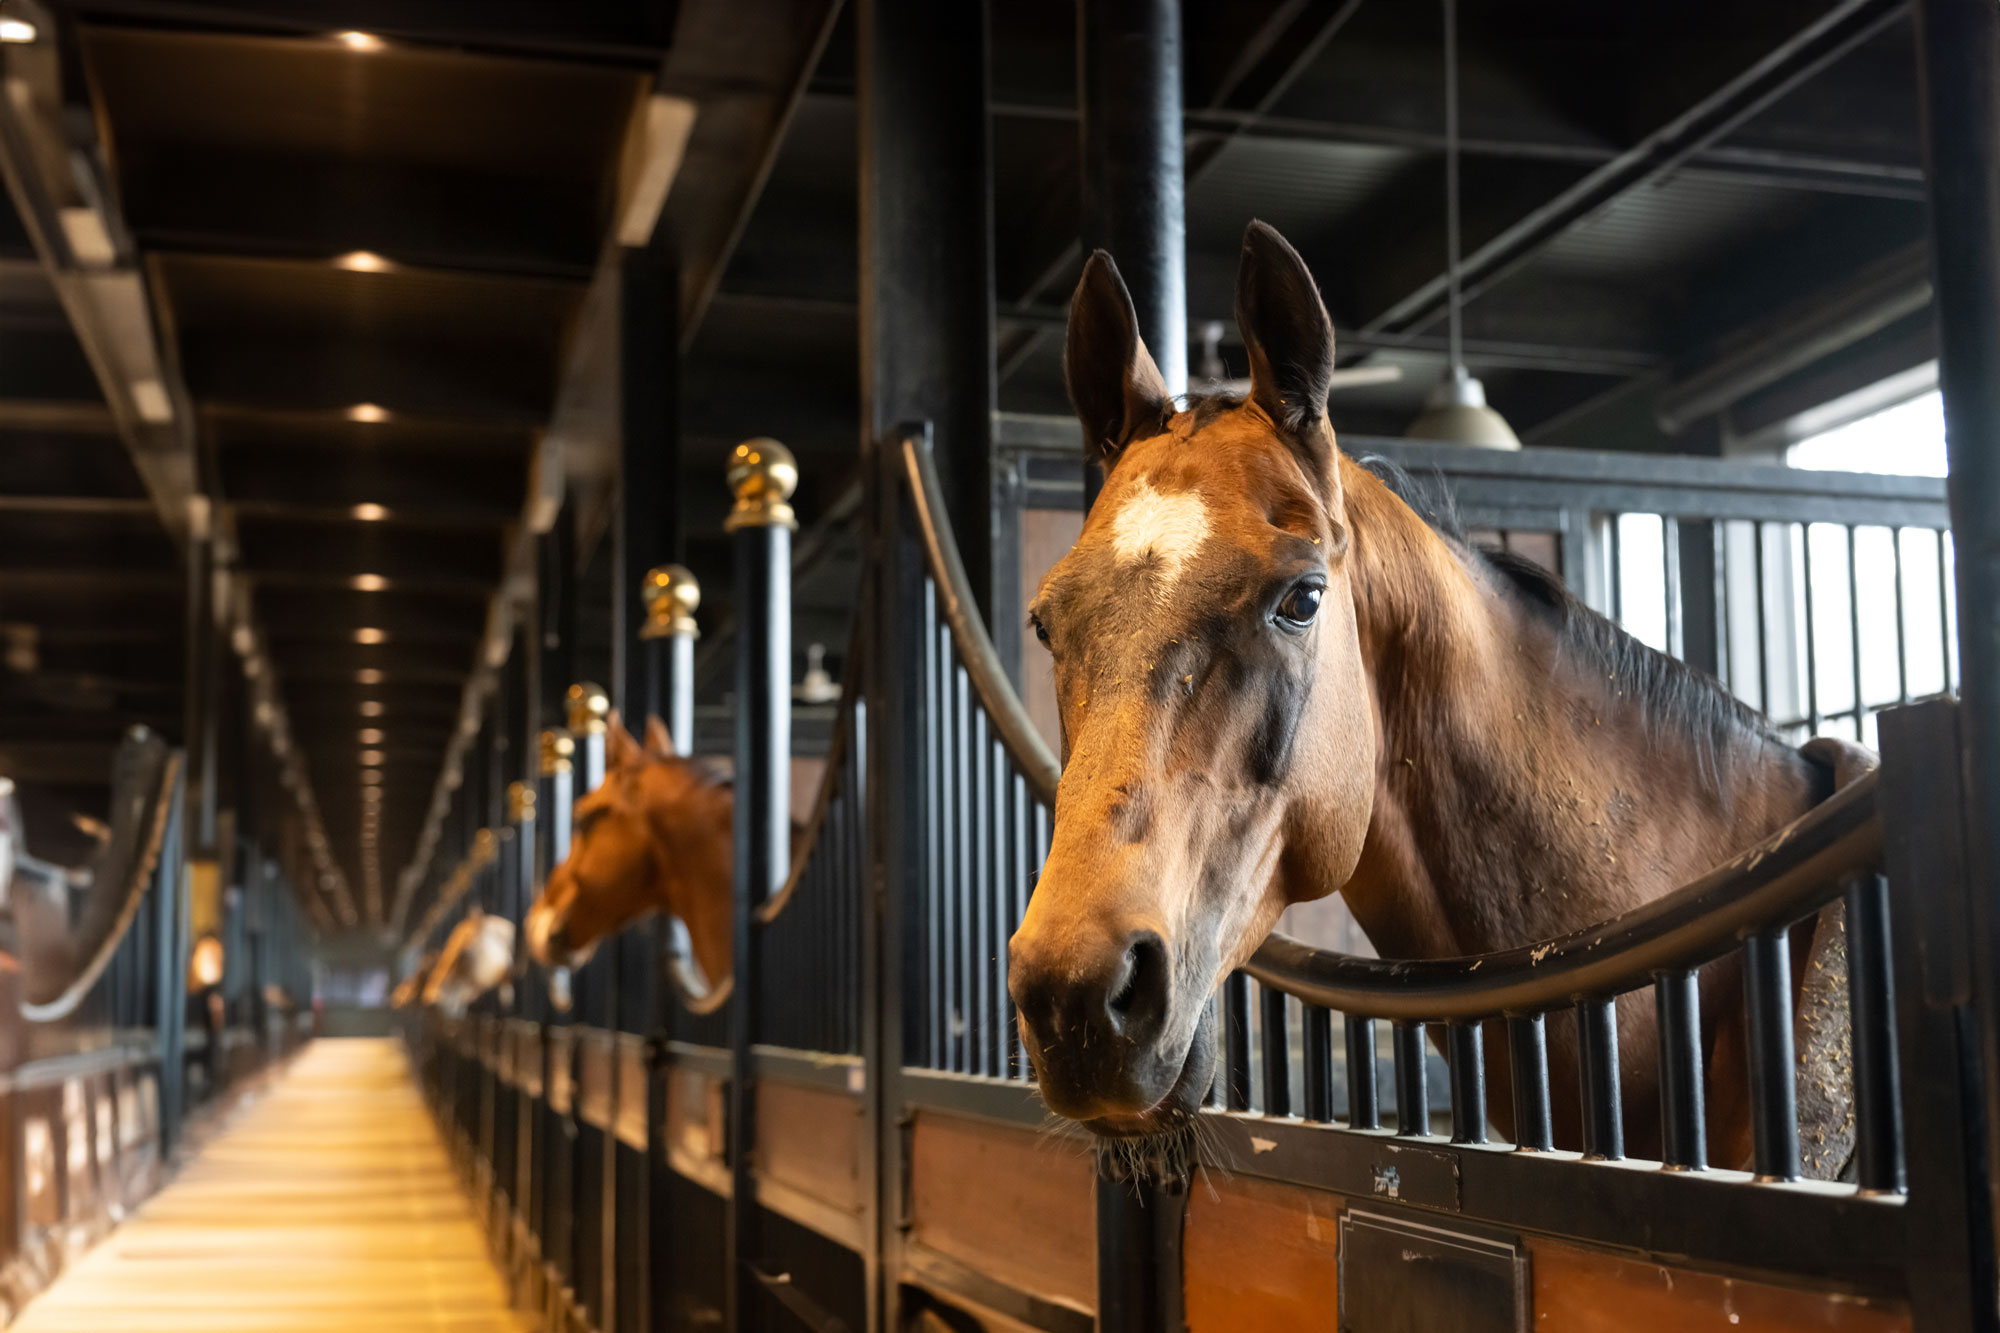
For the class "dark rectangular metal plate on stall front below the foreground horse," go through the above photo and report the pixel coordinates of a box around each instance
[1340,1209,1532,1333]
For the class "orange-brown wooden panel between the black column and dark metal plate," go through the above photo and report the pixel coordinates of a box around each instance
[1182,1175,1342,1333]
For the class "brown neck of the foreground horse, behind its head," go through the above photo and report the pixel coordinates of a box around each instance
[1344,466,1816,957]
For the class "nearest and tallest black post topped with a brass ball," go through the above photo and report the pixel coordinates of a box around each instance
[726,440,798,1333]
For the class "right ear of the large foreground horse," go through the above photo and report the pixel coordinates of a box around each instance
[1236,222,1334,476]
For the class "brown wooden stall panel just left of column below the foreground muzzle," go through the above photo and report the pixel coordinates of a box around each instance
[910,1111,1098,1309]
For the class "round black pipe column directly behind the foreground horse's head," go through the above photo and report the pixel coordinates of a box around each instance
[1076,0,1188,1333]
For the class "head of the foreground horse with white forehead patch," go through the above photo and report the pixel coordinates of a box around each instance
[1010,224,1376,1133]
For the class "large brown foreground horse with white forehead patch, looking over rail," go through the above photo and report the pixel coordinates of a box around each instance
[1008,222,1856,1165]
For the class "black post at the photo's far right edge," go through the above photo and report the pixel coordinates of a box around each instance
[1916,0,2000,1232]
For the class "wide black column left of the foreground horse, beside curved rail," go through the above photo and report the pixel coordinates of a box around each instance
[860,0,1014,1329]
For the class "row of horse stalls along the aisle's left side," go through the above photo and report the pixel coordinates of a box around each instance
[0,729,312,1319]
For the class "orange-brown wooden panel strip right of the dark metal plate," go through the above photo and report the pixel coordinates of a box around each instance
[1528,1241,1910,1333]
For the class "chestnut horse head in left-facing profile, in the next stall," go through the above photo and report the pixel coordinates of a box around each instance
[526,717,736,987]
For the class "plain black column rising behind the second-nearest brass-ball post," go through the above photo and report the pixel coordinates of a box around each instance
[612,239,680,716]
